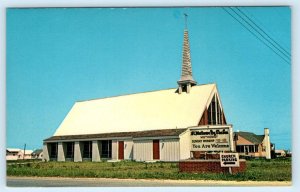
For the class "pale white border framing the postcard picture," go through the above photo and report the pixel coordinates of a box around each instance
[0,0,300,192]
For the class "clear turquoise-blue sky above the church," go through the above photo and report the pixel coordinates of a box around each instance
[6,7,292,149]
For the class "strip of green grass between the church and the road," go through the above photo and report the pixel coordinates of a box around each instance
[7,159,292,181]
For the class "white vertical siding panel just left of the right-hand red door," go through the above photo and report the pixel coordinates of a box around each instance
[133,140,153,161]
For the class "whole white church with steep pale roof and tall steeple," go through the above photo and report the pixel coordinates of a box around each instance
[43,17,234,162]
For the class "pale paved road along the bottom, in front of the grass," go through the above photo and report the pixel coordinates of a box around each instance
[7,177,291,187]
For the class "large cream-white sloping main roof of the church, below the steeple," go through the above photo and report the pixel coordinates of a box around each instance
[54,84,217,136]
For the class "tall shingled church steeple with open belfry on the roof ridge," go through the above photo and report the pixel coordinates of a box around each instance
[177,14,197,94]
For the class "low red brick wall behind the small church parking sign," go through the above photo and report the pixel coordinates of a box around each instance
[179,159,246,174]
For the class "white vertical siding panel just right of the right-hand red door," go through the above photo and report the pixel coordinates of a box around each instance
[159,139,179,161]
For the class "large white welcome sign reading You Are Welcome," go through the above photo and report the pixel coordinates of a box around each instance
[191,127,230,151]
